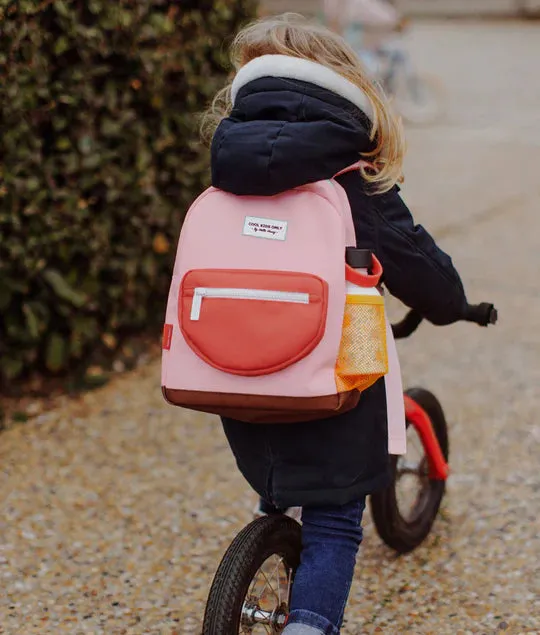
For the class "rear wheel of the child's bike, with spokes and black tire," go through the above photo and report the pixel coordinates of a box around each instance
[202,515,302,635]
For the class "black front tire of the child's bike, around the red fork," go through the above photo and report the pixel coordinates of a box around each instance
[370,388,449,553]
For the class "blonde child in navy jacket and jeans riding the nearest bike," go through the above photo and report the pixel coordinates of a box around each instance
[202,16,466,635]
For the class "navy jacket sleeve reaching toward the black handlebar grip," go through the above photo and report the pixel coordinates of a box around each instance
[372,187,467,325]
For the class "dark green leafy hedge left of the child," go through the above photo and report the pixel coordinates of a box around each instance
[0,0,254,386]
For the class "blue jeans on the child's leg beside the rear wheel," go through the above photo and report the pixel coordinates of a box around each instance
[283,498,366,635]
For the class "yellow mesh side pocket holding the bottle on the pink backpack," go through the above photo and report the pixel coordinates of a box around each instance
[336,296,388,392]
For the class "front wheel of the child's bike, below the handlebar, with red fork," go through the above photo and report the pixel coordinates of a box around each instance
[370,388,448,553]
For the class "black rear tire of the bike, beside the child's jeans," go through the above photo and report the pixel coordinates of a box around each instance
[202,515,302,635]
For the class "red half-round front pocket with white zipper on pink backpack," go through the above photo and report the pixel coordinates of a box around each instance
[178,269,328,376]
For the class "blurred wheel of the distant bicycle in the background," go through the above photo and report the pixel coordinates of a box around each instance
[392,73,444,126]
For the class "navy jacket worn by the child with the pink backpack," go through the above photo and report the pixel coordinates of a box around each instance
[212,77,466,507]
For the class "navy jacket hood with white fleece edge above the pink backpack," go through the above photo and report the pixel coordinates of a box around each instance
[212,55,372,196]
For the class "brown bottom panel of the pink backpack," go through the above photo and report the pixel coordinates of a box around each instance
[162,386,360,423]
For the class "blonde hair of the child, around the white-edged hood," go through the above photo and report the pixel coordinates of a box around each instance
[201,13,405,193]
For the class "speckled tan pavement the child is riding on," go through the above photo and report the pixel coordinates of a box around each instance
[0,19,540,635]
